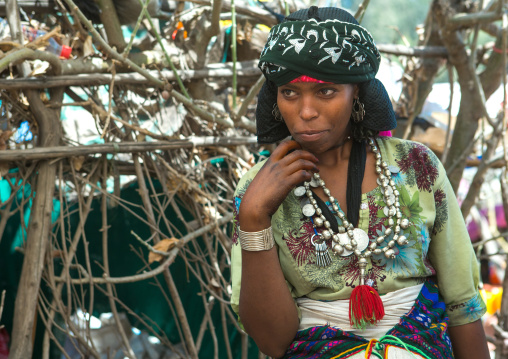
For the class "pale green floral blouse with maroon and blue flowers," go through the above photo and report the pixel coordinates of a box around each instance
[231,137,486,326]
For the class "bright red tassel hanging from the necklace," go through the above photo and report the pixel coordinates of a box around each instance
[349,285,385,329]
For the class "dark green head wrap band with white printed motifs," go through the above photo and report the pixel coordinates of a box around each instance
[259,19,381,86]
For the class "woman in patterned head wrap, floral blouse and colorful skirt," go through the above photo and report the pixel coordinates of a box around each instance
[232,7,489,359]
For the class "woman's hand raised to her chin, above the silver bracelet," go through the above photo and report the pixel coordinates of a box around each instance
[239,140,319,232]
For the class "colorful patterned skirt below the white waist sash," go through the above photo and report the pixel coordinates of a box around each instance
[284,282,453,359]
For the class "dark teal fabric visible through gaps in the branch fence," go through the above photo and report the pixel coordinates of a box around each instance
[0,179,258,359]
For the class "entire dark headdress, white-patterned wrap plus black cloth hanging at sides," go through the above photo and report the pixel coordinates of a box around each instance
[256,6,396,143]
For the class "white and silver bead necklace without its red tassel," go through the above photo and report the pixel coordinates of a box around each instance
[294,138,409,285]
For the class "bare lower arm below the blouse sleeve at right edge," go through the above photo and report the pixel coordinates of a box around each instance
[448,320,490,359]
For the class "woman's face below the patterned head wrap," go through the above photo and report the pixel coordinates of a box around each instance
[277,82,358,155]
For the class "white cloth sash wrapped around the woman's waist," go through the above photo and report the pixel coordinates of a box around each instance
[296,284,423,340]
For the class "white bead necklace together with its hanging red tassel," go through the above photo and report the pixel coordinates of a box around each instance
[294,138,409,327]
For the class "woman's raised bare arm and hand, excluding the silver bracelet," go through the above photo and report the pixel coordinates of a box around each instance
[239,141,318,358]
